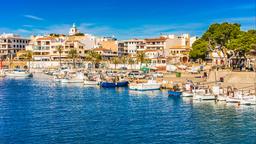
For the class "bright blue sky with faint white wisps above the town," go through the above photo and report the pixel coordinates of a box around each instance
[0,0,256,39]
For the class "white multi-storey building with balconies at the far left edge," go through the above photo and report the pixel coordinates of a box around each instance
[0,34,30,57]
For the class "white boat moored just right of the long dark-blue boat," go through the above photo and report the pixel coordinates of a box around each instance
[129,80,161,91]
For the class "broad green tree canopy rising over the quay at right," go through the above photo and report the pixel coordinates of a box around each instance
[189,22,256,60]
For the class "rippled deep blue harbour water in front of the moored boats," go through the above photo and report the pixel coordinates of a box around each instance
[0,77,256,144]
